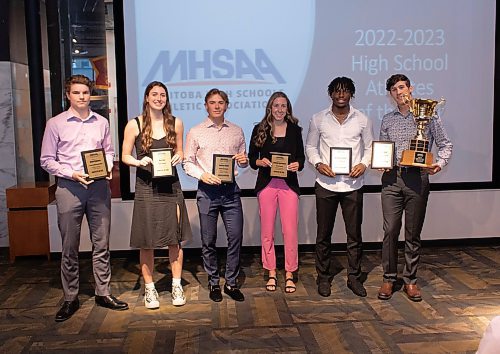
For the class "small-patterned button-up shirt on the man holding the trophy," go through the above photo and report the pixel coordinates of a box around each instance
[380,109,453,168]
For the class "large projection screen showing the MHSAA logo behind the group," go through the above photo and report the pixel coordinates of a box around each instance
[124,0,496,190]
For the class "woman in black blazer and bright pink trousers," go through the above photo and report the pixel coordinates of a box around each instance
[248,92,305,293]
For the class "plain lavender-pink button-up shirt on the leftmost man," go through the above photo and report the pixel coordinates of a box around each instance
[40,108,114,179]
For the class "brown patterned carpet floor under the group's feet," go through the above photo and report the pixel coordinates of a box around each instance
[0,245,500,353]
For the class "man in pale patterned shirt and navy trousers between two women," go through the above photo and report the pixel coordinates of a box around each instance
[184,89,248,302]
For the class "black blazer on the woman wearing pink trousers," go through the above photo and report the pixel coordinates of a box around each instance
[248,122,305,194]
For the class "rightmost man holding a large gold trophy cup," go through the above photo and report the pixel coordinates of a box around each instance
[378,74,453,302]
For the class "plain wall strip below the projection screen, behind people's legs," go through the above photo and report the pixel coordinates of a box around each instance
[49,190,500,252]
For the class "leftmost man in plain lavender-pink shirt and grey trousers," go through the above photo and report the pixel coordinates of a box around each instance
[40,75,128,322]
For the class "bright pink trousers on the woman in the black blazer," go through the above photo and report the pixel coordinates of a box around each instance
[258,178,299,272]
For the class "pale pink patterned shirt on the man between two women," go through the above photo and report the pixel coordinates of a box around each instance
[183,118,246,179]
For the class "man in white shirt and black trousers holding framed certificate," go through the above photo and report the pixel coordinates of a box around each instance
[305,77,373,297]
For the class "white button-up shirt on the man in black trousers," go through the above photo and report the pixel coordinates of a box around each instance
[305,106,373,192]
